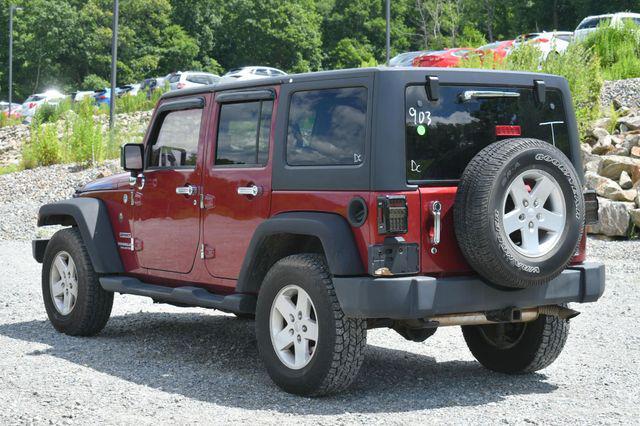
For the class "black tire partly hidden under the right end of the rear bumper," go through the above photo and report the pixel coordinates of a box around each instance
[462,315,569,374]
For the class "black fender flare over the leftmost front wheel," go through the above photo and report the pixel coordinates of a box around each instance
[38,197,124,274]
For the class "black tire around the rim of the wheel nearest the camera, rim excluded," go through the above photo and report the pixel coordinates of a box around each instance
[256,254,367,396]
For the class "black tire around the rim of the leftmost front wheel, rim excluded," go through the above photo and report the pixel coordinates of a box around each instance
[42,228,113,336]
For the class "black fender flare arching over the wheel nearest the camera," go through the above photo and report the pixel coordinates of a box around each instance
[236,212,365,293]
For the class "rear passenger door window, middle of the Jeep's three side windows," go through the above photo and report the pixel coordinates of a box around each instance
[215,101,273,165]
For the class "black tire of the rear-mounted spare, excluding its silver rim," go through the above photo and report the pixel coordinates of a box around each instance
[454,139,585,288]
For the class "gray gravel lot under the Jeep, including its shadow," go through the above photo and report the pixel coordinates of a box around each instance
[0,239,640,425]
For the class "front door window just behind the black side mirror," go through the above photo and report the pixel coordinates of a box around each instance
[147,109,202,168]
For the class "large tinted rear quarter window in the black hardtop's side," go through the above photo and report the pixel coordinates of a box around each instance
[287,87,367,166]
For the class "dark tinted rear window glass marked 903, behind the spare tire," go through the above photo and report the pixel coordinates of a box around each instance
[405,85,570,182]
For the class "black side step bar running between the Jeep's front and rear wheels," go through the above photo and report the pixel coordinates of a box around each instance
[100,276,256,314]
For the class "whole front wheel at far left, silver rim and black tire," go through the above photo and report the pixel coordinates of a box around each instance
[42,228,113,336]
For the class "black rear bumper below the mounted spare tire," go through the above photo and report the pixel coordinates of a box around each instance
[333,262,605,319]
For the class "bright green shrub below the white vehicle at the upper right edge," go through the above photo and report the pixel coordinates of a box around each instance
[583,22,640,80]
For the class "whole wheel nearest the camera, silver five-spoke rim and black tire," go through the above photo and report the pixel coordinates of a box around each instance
[256,254,367,395]
